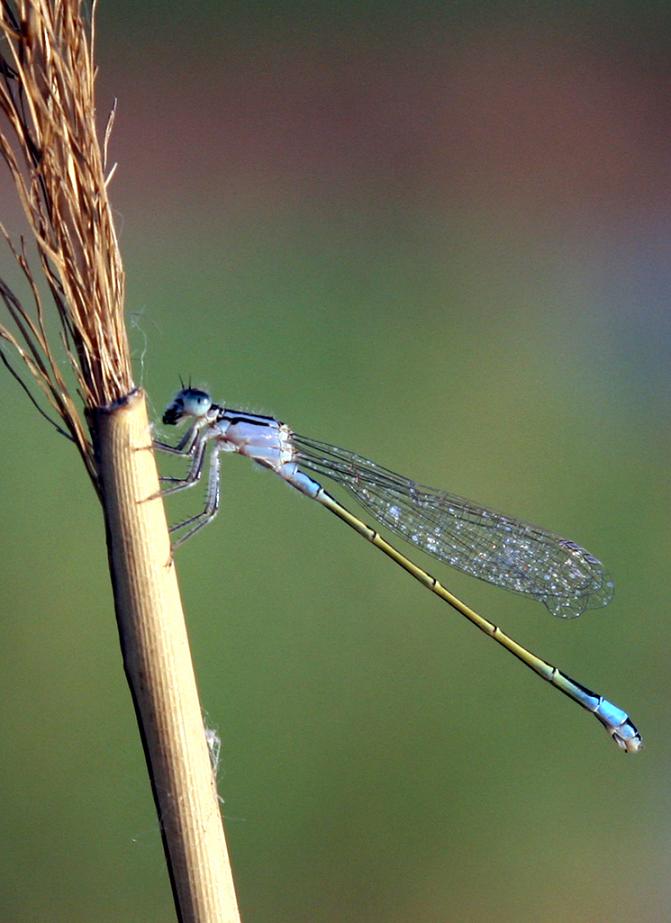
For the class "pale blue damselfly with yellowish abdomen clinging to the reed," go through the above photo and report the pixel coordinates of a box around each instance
[155,385,643,753]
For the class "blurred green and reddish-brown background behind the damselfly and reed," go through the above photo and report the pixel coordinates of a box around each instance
[0,0,671,923]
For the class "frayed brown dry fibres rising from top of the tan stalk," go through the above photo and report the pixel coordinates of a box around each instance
[0,0,133,490]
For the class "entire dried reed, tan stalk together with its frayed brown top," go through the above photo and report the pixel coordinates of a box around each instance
[0,0,238,921]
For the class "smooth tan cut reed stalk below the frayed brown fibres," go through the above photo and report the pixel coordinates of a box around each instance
[92,392,240,923]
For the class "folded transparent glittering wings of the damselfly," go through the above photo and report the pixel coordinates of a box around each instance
[293,434,613,618]
